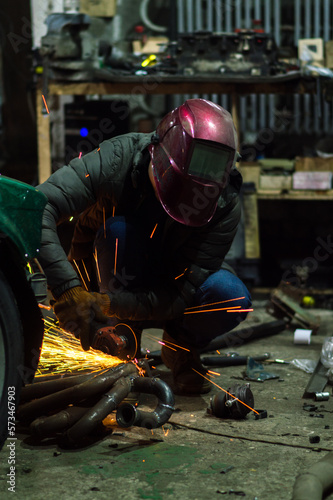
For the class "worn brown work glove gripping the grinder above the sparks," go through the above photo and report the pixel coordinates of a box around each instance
[52,286,110,351]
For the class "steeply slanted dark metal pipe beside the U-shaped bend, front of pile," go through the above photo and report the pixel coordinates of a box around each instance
[66,376,132,444]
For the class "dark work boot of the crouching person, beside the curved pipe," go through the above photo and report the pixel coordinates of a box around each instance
[161,331,212,395]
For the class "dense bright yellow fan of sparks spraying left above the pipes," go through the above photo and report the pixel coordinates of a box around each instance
[37,318,123,376]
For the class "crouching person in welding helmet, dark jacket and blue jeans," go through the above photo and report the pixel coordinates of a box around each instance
[38,99,251,394]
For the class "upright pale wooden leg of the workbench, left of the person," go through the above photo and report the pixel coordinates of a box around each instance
[36,87,52,184]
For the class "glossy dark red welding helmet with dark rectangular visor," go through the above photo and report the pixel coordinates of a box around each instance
[148,99,237,226]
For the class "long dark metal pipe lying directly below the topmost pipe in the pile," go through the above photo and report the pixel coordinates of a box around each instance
[17,363,138,421]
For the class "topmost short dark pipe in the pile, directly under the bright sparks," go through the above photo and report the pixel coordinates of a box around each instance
[20,370,99,404]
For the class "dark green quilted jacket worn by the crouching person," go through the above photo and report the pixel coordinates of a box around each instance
[38,133,242,321]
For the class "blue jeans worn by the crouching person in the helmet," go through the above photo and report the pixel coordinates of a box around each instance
[95,217,251,348]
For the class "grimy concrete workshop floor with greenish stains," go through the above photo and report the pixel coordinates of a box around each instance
[0,301,333,500]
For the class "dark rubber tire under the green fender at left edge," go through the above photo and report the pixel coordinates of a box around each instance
[0,270,24,450]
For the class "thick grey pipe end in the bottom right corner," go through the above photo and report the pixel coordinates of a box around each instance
[292,452,333,500]
